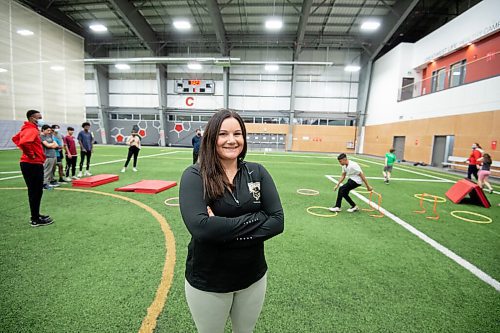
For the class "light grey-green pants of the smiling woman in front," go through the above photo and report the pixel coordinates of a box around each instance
[185,273,267,333]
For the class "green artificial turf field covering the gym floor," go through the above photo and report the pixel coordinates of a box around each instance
[0,146,500,333]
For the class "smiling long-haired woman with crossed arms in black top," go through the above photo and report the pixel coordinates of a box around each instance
[179,109,284,333]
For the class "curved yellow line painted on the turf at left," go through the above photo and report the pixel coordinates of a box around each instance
[0,187,175,333]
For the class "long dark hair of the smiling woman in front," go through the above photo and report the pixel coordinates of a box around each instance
[198,109,247,202]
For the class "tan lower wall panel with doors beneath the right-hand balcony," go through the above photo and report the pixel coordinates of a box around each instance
[364,110,500,163]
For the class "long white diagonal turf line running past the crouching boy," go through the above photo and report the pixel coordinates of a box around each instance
[326,176,500,292]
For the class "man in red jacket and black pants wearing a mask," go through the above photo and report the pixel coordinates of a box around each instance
[12,110,54,227]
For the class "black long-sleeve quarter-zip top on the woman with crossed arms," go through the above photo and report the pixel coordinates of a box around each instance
[179,162,284,293]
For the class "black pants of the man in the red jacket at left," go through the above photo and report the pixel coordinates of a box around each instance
[20,162,43,221]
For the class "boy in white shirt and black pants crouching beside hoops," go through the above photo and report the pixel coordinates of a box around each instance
[329,153,373,213]
